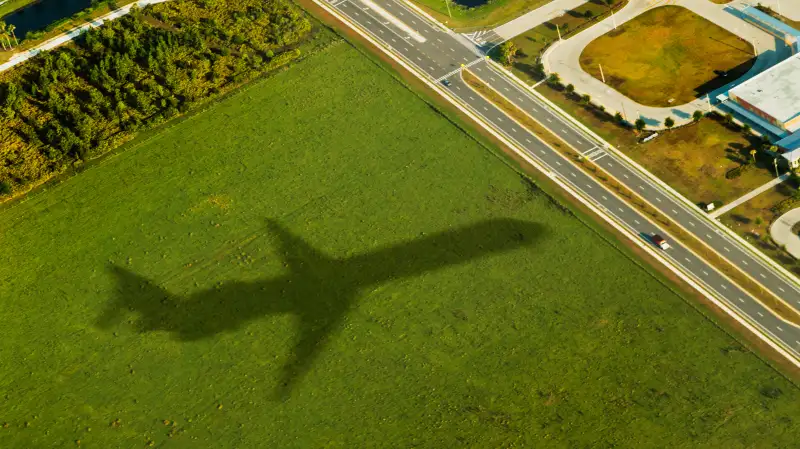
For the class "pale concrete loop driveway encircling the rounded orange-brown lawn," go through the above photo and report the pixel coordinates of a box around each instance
[542,0,791,129]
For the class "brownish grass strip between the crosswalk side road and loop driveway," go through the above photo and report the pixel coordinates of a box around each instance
[511,0,628,82]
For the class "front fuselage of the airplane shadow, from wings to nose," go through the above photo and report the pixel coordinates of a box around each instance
[344,219,545,286]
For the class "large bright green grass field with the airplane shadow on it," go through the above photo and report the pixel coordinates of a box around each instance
[0,39,800,449]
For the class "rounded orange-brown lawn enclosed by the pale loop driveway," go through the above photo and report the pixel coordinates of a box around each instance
[580,6,755,106]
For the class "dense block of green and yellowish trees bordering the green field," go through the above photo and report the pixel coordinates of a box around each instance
[0,0,311,194]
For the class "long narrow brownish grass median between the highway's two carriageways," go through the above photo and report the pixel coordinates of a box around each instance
[462,70,800,324]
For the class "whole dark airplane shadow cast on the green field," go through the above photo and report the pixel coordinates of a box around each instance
[96,219,545,399]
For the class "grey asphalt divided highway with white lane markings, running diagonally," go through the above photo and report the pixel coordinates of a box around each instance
[318,0,800,359]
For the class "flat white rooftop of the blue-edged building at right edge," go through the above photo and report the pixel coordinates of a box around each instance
[730,53,800,131]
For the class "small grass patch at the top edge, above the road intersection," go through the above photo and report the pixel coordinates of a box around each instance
[413,0,552,31]
